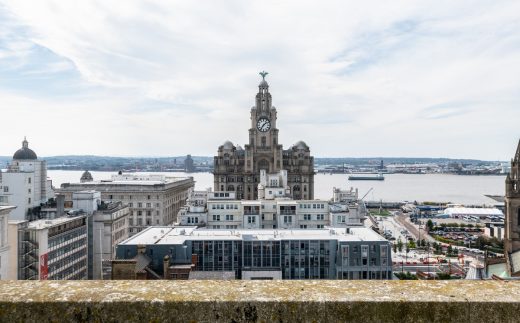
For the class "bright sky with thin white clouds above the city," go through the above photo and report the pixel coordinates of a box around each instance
[0,0,520,160]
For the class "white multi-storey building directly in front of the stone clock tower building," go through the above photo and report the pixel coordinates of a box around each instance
[178,170,366,229]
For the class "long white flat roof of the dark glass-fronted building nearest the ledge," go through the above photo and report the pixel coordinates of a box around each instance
[120,226,386,245]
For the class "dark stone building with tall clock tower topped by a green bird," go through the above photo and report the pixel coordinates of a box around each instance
[213,73,314,200]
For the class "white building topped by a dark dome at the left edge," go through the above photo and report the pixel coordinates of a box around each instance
[0,139,54,220]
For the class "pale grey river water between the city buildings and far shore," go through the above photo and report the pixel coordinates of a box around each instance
[48,170,505,204]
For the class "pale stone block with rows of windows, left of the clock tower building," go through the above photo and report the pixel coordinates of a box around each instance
[58,172,195,235]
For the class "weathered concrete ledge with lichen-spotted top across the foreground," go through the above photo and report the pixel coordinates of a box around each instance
[0,280,520,322]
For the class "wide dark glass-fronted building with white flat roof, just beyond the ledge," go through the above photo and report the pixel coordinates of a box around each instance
[114,225,392,279]
